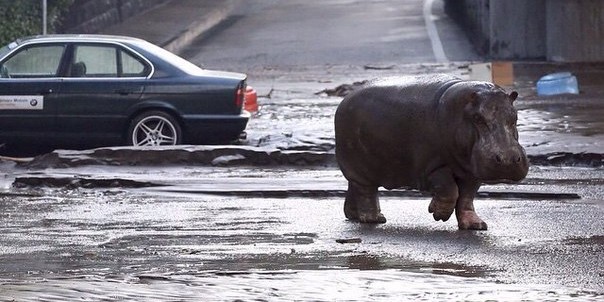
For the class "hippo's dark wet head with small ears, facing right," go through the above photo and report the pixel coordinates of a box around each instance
[439,82,528,183]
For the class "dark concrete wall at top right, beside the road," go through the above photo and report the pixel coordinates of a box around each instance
[444,0,604,61]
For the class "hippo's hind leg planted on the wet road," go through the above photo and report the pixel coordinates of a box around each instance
[344,181,386,223]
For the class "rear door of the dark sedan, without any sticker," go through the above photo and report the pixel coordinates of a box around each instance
[57,43,151,145]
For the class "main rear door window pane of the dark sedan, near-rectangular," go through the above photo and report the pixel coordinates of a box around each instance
[69,45,117,78]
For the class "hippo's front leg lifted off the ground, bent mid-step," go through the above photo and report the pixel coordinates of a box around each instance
[428,168,459,221]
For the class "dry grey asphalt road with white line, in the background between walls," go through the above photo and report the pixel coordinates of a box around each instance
[184,0,478,72]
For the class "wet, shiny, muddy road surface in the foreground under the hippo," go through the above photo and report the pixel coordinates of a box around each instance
[0,166,604,301]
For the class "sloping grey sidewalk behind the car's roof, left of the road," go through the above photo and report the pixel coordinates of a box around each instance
[100,0,239,53]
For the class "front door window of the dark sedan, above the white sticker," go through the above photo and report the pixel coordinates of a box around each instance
[2,45,65,78]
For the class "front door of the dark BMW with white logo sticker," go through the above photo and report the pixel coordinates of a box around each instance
[0,43,66,144]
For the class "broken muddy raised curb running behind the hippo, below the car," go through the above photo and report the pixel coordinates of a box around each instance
[18,145,604,169]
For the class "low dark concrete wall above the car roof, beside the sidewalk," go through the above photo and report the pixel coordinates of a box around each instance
[57,0,167,34]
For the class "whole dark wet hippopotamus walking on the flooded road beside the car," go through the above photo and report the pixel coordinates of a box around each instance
[335,75,529,230]
